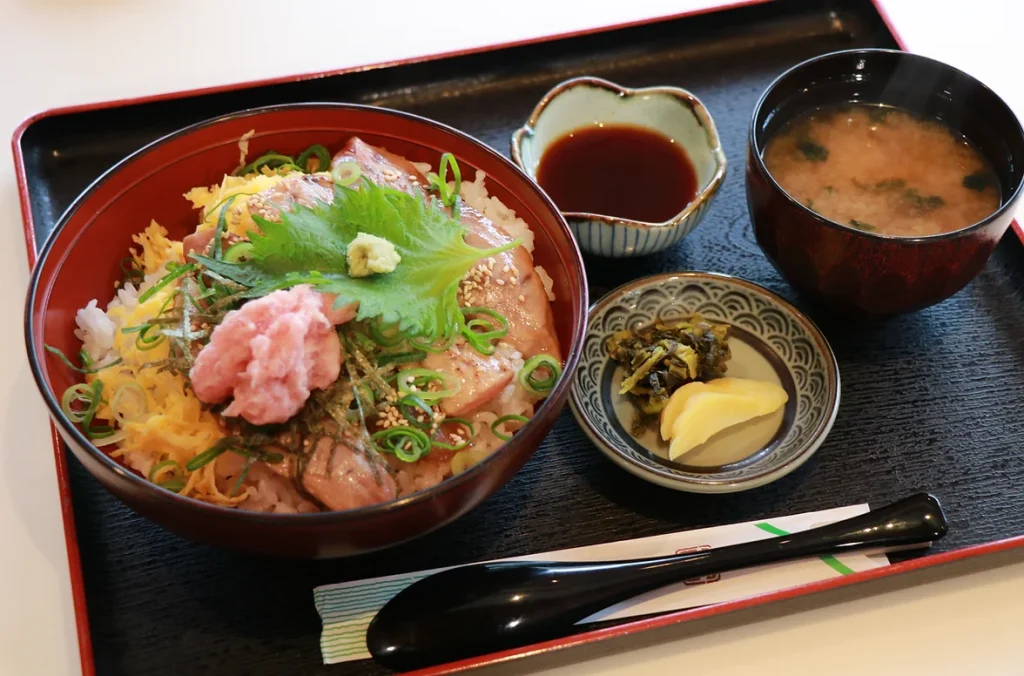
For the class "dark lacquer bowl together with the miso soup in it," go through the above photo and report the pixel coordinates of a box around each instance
[746,49,1024,316]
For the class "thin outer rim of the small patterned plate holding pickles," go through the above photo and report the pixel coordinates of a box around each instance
[569,270,843,494]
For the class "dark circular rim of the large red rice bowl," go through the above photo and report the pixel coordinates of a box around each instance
[25,101,589,522]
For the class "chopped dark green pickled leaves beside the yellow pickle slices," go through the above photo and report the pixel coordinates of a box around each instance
[605,314,732,435]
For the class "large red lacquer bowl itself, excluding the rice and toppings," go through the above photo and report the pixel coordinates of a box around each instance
[26,103,588,558]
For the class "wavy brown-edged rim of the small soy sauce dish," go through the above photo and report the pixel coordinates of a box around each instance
[511,75,728,230]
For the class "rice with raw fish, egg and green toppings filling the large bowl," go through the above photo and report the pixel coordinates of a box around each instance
[46,134,563,513]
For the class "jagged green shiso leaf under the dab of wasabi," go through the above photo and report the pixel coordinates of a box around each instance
[193,180,520,340]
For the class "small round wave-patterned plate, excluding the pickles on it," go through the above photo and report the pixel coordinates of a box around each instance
[569,272,840,493]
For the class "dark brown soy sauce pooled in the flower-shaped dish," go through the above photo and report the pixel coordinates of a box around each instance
[537,125,697,223]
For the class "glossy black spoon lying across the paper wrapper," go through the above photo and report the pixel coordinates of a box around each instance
[367,493,946,670]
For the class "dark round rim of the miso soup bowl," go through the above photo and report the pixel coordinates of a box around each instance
[748,47,1024,246]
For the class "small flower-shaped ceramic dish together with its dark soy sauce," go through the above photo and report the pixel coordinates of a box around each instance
[512,77,726,258]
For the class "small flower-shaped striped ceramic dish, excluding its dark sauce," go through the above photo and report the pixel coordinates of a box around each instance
[512,77,726,258]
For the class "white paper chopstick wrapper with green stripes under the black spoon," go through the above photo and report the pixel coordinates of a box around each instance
[313,505,889,664]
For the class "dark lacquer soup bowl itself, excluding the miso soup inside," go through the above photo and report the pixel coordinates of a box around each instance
[746,49,1024,316]
